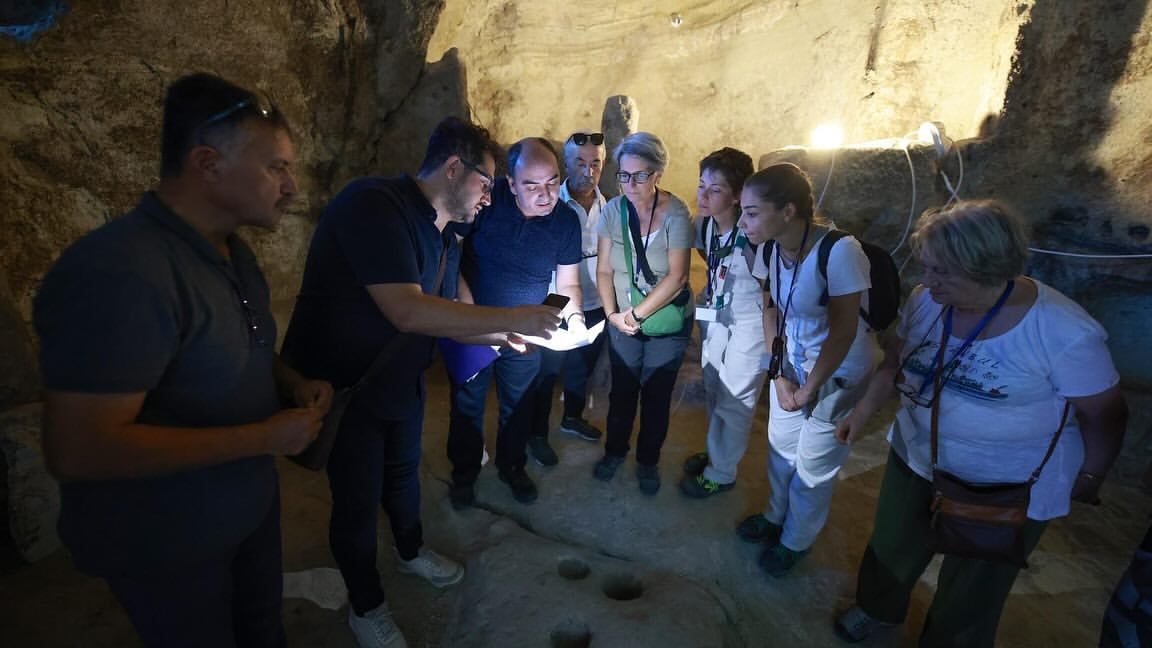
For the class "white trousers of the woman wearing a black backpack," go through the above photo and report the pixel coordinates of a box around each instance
[764,371,867,551]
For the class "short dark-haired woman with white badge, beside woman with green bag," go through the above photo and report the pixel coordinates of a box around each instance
[680,148,764,498]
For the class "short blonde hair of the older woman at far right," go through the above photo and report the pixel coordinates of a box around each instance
[911,201,1028,286]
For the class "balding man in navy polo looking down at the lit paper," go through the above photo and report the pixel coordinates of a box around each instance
[448,137,584,508]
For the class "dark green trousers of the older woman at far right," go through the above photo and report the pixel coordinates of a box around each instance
[856,451,1047,648]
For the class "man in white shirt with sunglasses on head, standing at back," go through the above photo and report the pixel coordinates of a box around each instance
[528,130,607,466]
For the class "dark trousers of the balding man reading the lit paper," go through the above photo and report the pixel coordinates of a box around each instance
[448,348,540,487]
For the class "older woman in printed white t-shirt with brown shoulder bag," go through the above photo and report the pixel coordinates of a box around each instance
[835,202,1127,647]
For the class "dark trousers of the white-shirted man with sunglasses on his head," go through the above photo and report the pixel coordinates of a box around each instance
[531,308,607,437]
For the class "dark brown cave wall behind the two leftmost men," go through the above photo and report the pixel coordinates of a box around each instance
[0,0,467,409]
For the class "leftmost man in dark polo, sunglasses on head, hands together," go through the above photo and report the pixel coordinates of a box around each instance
[35,74,332,647]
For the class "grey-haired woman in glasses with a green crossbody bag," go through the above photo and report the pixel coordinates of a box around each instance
[593,133,695,495]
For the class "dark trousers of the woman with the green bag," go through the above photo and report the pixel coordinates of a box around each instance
[604,321,691,466]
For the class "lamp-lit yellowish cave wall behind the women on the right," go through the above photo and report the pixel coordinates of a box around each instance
[429,0,1152,390]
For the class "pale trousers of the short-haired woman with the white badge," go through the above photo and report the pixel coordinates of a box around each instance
[700,312,765,484]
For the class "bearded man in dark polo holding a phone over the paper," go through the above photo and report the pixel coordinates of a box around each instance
[283,118,560,648]
